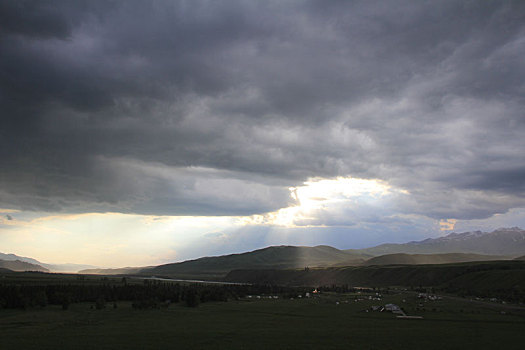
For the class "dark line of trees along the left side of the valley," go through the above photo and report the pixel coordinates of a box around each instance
[0,278,310,309]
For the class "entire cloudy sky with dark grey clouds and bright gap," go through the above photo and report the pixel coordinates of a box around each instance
[0,0,525,266]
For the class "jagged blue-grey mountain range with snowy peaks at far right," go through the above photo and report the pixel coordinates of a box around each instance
[347,227,525,256]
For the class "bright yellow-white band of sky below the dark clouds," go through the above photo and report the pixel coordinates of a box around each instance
[0,178,525,267]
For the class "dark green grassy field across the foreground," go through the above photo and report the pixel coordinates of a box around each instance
[0,292,525,349]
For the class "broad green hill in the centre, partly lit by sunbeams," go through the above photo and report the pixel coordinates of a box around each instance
[141,246,369,278]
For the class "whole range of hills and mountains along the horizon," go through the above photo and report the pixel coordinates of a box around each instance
[0,227,525,279]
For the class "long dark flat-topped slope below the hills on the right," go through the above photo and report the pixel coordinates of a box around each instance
[225,260,525,292]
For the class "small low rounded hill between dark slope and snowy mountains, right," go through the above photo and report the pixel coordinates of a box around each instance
[363,253,509,265]
